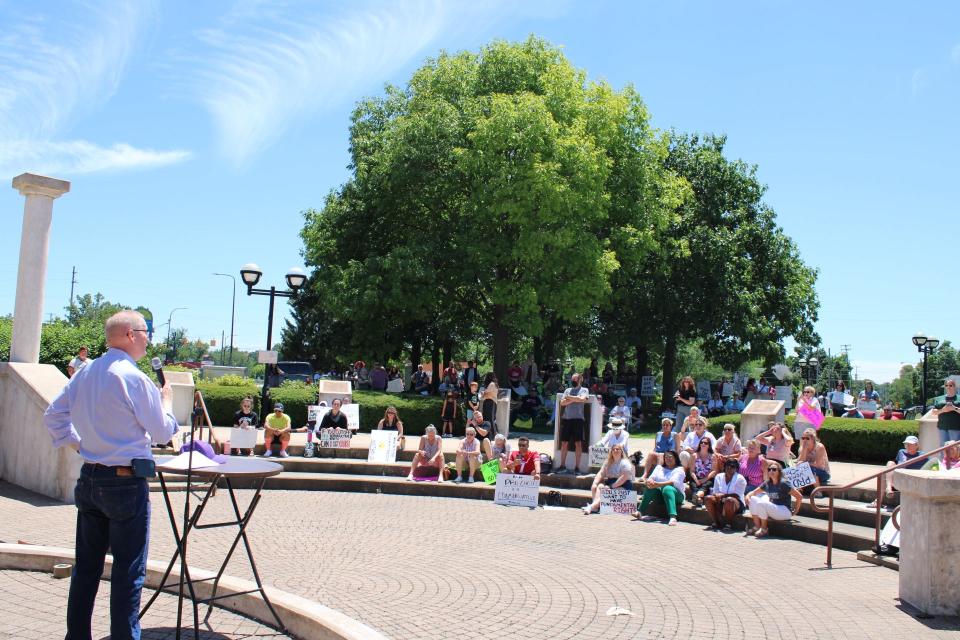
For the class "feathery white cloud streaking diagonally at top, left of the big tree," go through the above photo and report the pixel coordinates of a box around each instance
[192,0,549,165]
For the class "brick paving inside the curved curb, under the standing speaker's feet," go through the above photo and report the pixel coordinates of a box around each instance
[0,571,290,640]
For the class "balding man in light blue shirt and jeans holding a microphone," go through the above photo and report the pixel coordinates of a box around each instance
[44,310,178,640]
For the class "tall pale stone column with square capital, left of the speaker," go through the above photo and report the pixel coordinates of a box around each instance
[10,173,70,363]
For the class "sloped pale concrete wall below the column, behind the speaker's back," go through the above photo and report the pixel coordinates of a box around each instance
[0,362,82,502]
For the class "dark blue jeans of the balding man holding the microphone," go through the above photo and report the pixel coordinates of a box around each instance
[66,464,150,640]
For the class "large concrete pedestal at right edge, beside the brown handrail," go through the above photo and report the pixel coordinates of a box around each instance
[894,470,960,616]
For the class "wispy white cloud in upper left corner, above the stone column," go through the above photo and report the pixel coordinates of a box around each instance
[0,0,188,175]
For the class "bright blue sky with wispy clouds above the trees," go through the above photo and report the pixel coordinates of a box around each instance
[0,0,960,381]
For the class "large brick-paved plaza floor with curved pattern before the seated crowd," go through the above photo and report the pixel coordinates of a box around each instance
[0,483,960,640]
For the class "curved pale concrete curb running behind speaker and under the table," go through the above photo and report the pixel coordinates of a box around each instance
[0,543,388,640]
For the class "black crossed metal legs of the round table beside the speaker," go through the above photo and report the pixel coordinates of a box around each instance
[139,470,286,640]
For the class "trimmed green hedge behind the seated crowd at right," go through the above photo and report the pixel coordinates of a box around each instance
[709,414,920,464]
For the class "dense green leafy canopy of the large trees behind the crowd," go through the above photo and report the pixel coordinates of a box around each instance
[281,37,817,392]
